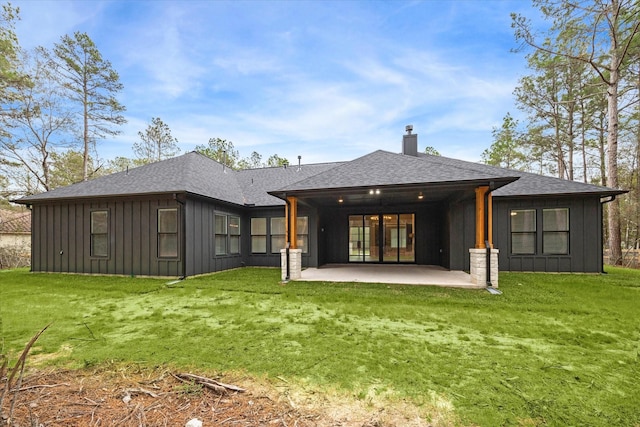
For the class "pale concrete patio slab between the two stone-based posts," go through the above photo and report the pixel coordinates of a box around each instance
[297,264,485,289]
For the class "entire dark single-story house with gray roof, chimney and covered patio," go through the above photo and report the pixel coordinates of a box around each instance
[17,127,624,283]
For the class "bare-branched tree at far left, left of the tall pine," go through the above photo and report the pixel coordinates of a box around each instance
[0,47,73,193]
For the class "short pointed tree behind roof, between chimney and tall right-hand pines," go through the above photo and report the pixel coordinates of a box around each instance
[482,113,526,170]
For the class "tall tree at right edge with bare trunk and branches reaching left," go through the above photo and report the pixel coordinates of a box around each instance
[512,0,640,264]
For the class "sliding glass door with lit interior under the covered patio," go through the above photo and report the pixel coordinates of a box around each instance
[349,214,415,263]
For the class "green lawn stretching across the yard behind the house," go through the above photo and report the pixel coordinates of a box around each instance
[0,268,640,426]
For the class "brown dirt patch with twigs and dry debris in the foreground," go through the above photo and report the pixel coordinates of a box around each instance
[2,366,444,427]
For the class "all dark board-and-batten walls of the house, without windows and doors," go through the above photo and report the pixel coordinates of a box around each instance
[25,194,602,276]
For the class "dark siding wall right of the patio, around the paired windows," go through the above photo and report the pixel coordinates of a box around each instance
[493,196,603,273]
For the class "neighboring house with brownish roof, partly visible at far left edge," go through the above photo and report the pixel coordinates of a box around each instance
[0,209,31,269]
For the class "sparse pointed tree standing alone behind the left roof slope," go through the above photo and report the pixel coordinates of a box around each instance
[133,117,180,164]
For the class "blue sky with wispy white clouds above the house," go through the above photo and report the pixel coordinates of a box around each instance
[12,0,535,163]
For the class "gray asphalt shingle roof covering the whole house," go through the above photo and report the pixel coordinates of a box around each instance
[19,150,622,206]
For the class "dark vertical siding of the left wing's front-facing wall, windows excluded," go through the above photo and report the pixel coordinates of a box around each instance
[31,198,183,276]
